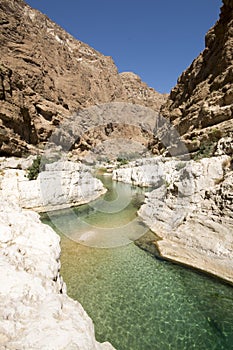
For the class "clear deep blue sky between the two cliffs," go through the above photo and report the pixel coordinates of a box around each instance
[26,0,222,92]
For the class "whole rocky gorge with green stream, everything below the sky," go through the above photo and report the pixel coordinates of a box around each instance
[0,0,233,350]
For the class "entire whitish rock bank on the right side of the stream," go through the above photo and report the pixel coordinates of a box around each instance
[113,155,233,283]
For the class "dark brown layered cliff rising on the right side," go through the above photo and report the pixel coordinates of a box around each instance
[160,0,233,155]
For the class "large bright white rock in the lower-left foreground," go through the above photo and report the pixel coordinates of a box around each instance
[0,200,113,350]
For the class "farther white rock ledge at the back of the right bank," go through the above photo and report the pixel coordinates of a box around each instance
[113,156,228,190]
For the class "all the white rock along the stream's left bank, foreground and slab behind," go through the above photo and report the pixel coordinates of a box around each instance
[0,159,113,350]
